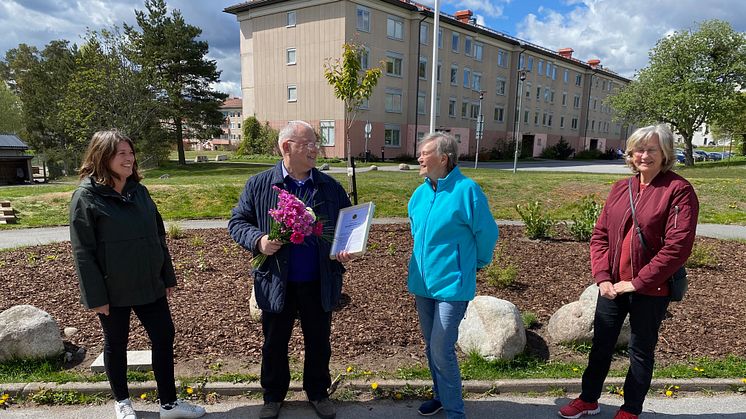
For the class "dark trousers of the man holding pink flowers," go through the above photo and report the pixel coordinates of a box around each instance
[261,281,332,402]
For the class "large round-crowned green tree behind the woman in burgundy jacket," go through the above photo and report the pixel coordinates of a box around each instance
[609,20,746,166]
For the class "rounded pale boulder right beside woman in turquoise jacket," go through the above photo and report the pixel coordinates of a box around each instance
[458,296,526,360]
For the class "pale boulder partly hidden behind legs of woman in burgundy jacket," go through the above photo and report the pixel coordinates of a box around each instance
[547,284,631,346]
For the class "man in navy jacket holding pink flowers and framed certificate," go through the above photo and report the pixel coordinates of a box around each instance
[228,121,352,419]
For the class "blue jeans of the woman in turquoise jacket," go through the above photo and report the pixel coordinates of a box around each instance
[415,295,469,419]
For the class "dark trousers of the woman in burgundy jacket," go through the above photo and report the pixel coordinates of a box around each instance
[580,293,669,415]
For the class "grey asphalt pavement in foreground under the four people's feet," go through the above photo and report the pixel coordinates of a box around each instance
[0,393,746,419]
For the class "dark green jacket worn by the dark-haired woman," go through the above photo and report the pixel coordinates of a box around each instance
[70,177,176,308]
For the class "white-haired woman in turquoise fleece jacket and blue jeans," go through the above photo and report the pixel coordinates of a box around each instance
[408,132,498,419]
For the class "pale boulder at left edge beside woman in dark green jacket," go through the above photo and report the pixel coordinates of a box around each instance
[0,305,65,361]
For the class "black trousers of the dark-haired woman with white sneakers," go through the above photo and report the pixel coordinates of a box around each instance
[98,297,176,404]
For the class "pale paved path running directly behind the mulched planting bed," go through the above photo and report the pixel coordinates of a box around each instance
[0,218,746,249]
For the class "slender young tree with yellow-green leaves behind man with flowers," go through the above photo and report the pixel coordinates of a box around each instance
[324,43,381,193]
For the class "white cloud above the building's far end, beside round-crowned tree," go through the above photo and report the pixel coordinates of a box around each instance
[517,0,746,77]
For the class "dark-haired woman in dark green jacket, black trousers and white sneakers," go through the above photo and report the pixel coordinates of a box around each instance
[70,130,205,419]
